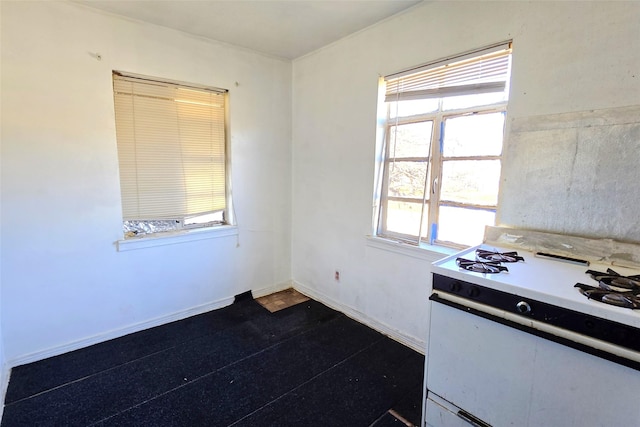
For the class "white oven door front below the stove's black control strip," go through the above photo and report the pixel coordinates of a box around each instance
[425,302,640,427]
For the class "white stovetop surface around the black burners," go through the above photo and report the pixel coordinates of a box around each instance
[432,244,640,328]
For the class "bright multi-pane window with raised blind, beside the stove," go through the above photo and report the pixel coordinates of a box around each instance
[375,43,511,246]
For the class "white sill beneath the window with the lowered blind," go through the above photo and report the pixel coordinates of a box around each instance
[116,225,238,252]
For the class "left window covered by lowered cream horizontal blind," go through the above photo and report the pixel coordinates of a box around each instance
[113,72,229,237]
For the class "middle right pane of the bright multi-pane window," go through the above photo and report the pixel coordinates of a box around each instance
[440,160,500,206]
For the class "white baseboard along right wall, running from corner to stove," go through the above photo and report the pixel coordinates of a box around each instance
[293,281,427,354]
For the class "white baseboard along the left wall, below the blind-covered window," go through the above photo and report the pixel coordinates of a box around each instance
[6,297,234,368]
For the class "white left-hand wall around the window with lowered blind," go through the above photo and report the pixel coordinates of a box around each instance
[1,1,291,364]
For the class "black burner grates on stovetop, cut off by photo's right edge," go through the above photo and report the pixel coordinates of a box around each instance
[574,268,640,309]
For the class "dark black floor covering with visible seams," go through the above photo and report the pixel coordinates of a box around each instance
[2,294,424,427]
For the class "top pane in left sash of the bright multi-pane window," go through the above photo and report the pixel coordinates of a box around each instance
[389,121,433,159]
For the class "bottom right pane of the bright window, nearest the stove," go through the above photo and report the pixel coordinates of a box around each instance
[438,206,496,246]
